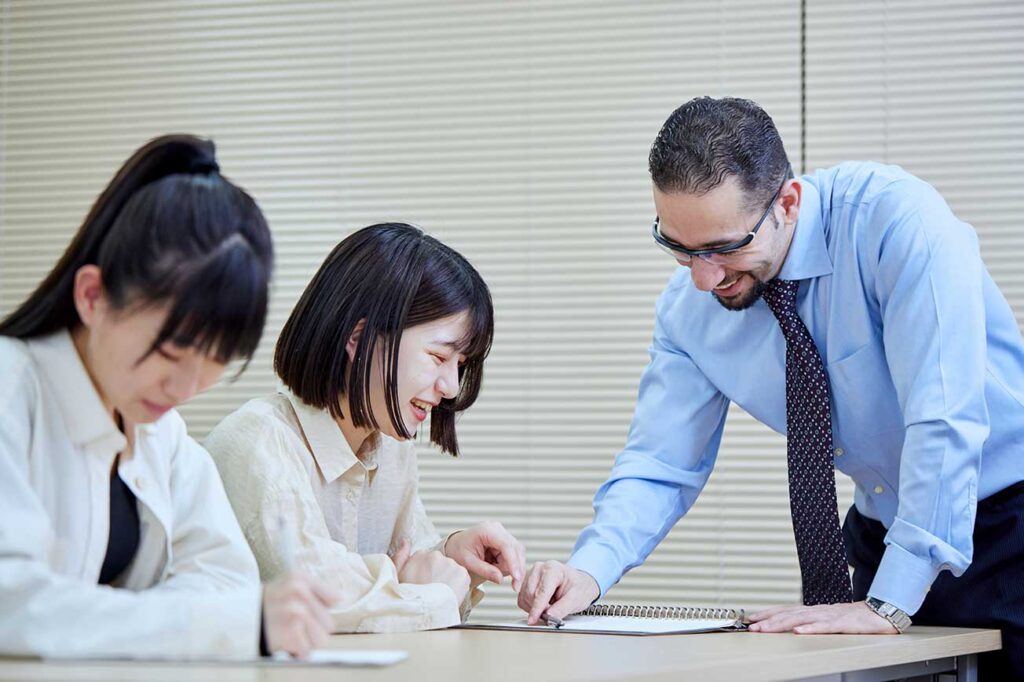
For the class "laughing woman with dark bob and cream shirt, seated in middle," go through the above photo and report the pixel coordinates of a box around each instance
[206,223,525,632]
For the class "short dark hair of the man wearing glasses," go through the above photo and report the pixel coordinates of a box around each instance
[648,97,790,208]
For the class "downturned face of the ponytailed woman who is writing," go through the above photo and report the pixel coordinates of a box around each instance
[73,266,225,423]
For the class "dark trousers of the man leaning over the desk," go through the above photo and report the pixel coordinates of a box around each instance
[843,481,1024,682]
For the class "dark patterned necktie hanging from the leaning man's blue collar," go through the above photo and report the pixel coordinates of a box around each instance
[763,280,853,605]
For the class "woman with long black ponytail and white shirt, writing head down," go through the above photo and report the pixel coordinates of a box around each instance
[0,135,336,658]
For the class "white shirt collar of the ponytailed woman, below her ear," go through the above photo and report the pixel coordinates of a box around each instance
[28,330,128,456]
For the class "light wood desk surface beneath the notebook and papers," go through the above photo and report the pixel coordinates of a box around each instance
[0,627,999,682]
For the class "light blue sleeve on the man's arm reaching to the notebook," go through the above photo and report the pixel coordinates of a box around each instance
[568,285,729,595]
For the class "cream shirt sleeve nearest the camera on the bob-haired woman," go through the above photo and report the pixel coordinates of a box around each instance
[206,413,460,633]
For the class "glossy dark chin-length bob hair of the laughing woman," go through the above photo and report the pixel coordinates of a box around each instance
[273,223,494,455]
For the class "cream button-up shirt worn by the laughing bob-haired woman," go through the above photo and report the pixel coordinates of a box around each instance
[205,390,482,632]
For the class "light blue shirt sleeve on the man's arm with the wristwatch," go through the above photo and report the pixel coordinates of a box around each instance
[868,181,989,613]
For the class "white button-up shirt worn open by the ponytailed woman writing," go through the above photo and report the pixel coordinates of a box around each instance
[0,332,261,658]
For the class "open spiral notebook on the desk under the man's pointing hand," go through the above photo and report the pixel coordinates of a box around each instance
[457,604,746,635]
